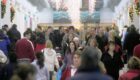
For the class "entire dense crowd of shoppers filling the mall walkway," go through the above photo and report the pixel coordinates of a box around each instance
[0,24,140,80]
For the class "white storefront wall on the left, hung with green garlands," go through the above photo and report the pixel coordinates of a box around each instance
[0,0,39,34]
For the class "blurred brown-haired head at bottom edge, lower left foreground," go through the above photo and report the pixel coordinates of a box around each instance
[12,64,35,80]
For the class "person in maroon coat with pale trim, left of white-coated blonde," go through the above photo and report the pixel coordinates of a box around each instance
[16,31,35,62]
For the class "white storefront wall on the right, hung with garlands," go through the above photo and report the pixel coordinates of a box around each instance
[114,0,140,31]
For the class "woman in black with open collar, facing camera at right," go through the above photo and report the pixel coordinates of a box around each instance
[101,41,123,80]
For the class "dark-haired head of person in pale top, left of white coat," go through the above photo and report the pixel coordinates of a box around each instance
[36,52,44,68]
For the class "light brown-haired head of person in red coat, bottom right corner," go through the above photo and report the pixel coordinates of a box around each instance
[128,56,140,70]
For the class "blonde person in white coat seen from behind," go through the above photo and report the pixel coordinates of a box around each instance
[42,40,59,80]
